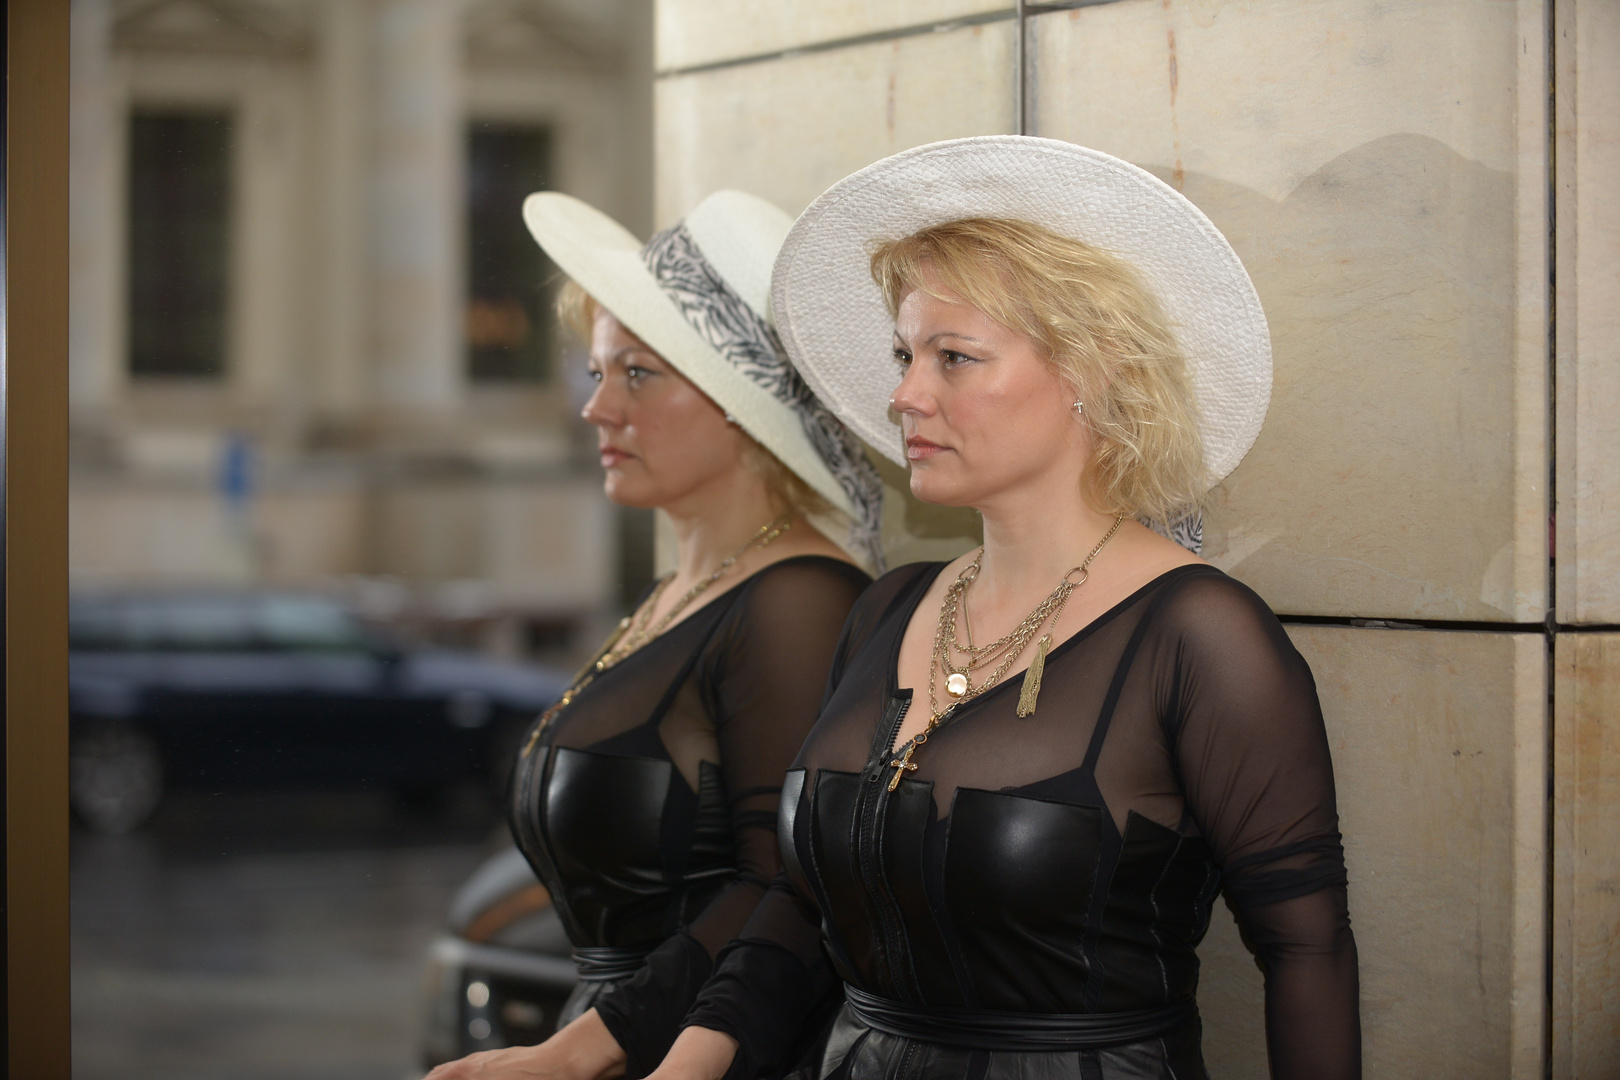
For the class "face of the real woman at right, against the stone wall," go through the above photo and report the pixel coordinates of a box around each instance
[893,288,1090,508]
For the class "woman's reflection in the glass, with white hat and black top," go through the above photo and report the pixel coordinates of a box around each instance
[431,191,880,1080]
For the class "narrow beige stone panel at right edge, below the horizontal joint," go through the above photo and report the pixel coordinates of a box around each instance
[1552,633,1620,1080]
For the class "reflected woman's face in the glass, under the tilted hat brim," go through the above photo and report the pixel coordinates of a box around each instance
[582,308,744,507]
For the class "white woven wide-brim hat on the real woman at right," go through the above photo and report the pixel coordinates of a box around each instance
[771,134,1272,484]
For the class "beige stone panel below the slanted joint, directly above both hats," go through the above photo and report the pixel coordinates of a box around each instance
[656,23,1014,225]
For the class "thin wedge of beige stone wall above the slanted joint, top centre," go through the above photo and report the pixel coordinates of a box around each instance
[656,0,1013,71]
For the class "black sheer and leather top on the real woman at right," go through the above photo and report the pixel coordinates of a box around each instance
[687,563,1361,1080]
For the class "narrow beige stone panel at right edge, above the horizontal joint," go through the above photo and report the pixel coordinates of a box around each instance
[1554,0,1620,623]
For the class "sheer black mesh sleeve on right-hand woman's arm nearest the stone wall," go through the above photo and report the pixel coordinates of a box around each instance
[1160,578,1361,1080]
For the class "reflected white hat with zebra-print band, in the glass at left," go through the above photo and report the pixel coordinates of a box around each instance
[523,191,883,565]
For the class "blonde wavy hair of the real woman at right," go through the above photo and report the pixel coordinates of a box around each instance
[872,217,1209,526]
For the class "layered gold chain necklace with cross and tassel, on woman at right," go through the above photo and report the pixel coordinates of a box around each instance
[889,513,1124,792]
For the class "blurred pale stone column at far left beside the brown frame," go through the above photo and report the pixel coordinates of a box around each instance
[68,0,123,415]
